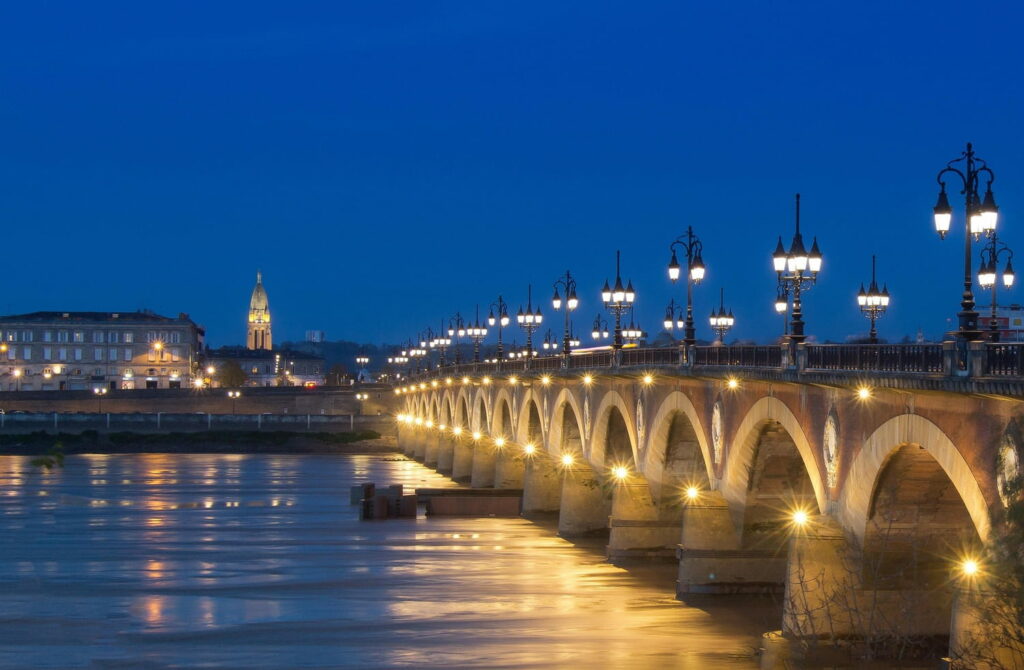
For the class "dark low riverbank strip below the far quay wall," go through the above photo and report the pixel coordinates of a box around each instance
[0,430,398,456]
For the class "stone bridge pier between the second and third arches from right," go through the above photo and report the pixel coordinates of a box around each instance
[676,491,786,597]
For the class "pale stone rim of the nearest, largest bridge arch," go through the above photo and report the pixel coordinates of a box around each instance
[840,414,991,542]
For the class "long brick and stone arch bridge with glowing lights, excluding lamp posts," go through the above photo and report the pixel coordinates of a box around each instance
[395,342,1024,663]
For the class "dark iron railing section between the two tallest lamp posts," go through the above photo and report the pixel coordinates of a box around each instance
[806,344,944,373]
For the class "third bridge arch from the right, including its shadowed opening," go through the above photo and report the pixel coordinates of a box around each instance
[643,390,715,496]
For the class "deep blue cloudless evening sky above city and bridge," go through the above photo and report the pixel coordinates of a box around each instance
[0,5,1024,345]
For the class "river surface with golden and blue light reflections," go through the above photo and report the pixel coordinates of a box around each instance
[0,454,779,669]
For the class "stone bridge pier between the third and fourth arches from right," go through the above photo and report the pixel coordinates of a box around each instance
[607,480,681,560]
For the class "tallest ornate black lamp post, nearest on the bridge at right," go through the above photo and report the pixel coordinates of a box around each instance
[932,142,999,340]
